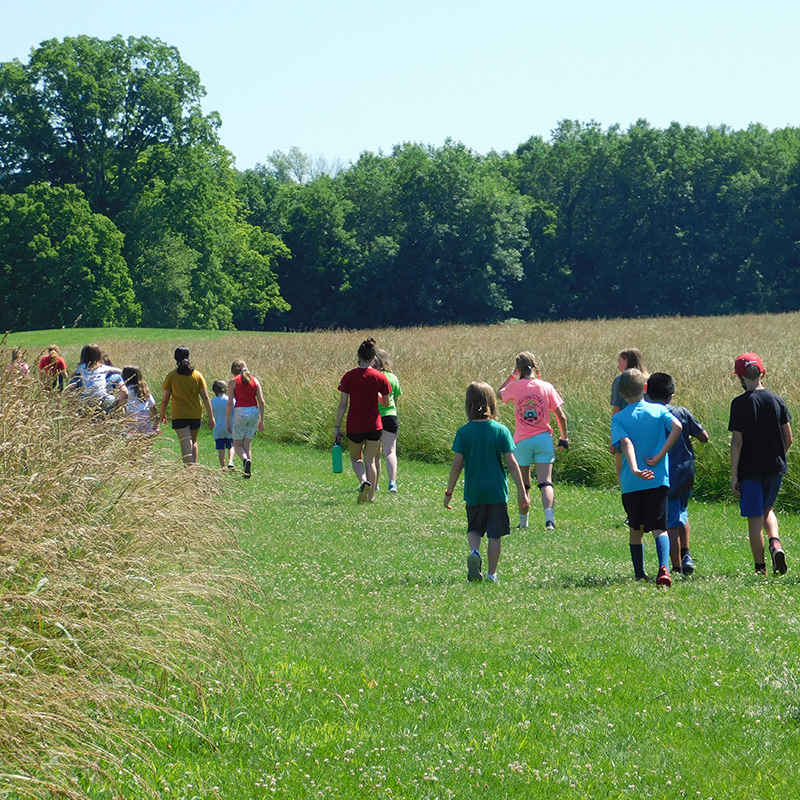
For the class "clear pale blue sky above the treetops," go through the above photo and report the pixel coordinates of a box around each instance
[0,0,800,169]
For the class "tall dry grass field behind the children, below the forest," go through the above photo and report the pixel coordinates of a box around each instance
[40,314,800,510]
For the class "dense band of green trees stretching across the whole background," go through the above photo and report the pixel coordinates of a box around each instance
[0,36,800,330]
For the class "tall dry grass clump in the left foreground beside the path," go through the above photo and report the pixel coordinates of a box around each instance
[0,350,249,798]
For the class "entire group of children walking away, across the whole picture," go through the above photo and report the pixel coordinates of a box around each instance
[12,338,792,587]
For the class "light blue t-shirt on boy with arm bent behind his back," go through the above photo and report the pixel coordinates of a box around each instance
[611,400,675,494]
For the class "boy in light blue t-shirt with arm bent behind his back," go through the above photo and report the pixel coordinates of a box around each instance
[611,369,682,588]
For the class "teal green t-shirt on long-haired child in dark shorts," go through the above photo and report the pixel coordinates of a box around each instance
[453,419,514,506]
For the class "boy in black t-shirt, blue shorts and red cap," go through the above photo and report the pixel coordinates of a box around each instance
[728,353,792,575]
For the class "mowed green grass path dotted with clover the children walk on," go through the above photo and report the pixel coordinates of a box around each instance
[130,430,800,800]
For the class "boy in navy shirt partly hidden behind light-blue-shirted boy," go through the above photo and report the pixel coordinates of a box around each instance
[647,372,709,575]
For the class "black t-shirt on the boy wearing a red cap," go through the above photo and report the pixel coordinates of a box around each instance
[728,389,792,481]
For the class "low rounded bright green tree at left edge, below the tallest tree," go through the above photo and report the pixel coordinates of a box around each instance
[0,184,140,330]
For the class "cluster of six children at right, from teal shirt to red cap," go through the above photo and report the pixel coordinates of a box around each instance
[444,348,792,588]
